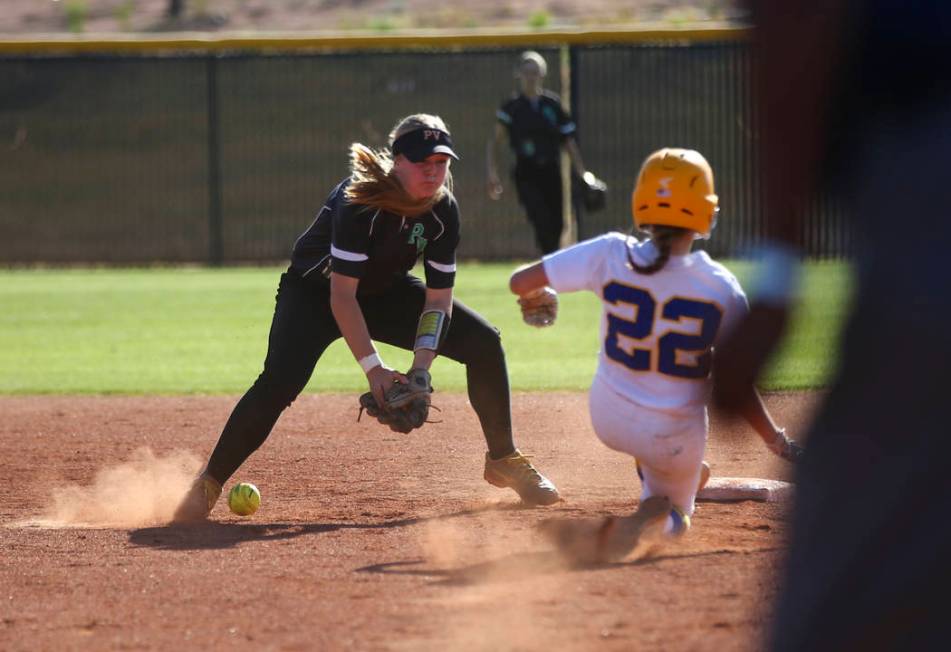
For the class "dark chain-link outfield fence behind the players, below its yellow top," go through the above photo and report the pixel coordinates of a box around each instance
[0,34,850,265]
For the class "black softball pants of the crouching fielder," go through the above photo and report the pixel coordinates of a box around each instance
[207,269,515,484]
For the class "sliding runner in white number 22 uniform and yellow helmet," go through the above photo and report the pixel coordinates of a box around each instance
[510,149,802,561]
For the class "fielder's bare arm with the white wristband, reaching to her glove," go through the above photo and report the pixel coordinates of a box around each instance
[330,273,405,405]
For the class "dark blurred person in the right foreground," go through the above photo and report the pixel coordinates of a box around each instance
[714,0,951,650]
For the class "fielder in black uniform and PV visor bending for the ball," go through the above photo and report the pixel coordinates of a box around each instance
[174,114,559,522]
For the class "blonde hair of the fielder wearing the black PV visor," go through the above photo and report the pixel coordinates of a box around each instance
[345,113,452,215]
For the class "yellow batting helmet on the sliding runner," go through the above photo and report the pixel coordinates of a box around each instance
[631,147,719,238]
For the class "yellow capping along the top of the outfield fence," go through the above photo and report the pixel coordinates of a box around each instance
[0,24,749,54]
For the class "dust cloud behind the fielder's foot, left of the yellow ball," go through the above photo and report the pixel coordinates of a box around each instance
[30,448,200,528]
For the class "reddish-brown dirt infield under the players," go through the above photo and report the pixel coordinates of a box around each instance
[0,393,816,652]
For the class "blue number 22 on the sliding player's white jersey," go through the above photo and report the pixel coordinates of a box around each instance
[603,281,723,379]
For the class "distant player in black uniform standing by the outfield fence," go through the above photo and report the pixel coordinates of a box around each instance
[486,51,585,254]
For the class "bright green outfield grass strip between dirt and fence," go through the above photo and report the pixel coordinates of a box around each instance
[0,263,850,394]
